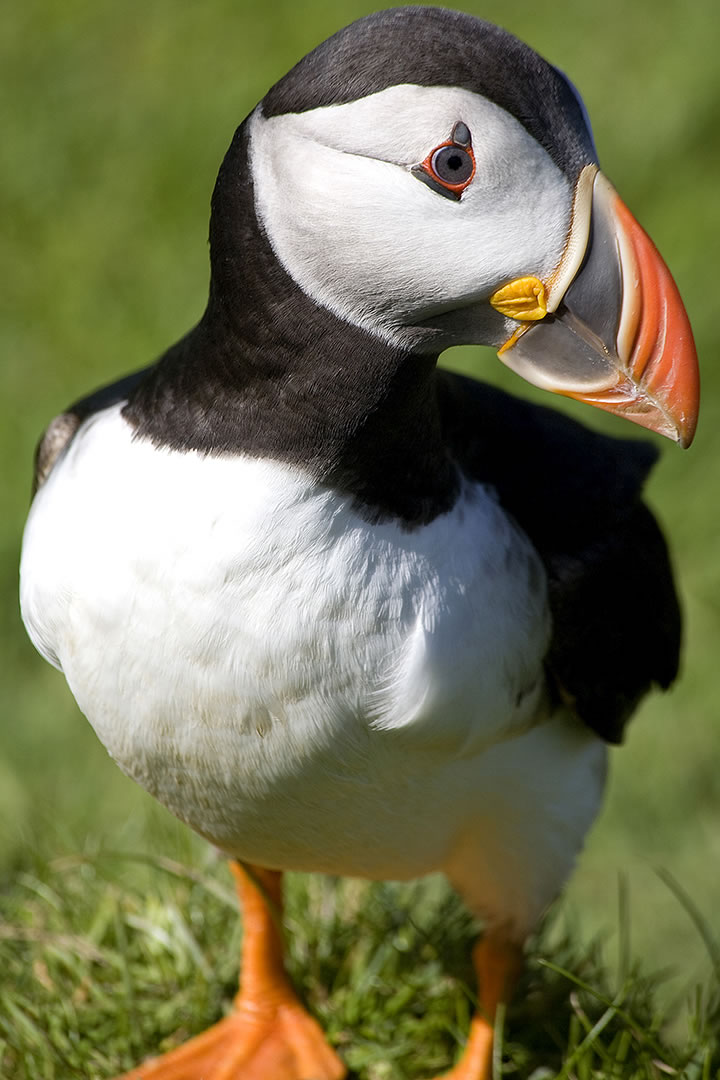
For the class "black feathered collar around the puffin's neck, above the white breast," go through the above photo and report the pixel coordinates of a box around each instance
[124,123,458,526]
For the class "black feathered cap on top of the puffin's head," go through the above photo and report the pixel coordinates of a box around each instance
[262,8,597,181]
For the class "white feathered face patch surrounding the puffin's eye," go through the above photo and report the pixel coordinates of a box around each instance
[250,85,572,340]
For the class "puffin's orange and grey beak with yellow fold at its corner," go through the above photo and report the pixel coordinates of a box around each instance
[490,165,699,447]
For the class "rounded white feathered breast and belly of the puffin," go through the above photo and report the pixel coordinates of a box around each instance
[22,408,608,928]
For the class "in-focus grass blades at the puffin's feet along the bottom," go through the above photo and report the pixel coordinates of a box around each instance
[0,851,720,1080]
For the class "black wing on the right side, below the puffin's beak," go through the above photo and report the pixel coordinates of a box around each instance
[438,372,680,743]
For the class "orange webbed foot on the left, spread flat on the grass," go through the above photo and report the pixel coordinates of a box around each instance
[117,1001,345,1080]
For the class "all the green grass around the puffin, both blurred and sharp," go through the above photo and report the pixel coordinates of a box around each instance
[0,0,720,1080]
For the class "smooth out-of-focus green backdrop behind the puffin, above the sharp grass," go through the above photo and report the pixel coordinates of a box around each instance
[0,0,720,1015]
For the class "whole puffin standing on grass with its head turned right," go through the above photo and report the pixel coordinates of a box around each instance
[21,6,698,1080]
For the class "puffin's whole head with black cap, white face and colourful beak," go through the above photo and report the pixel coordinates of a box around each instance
[212,8,698,446]
